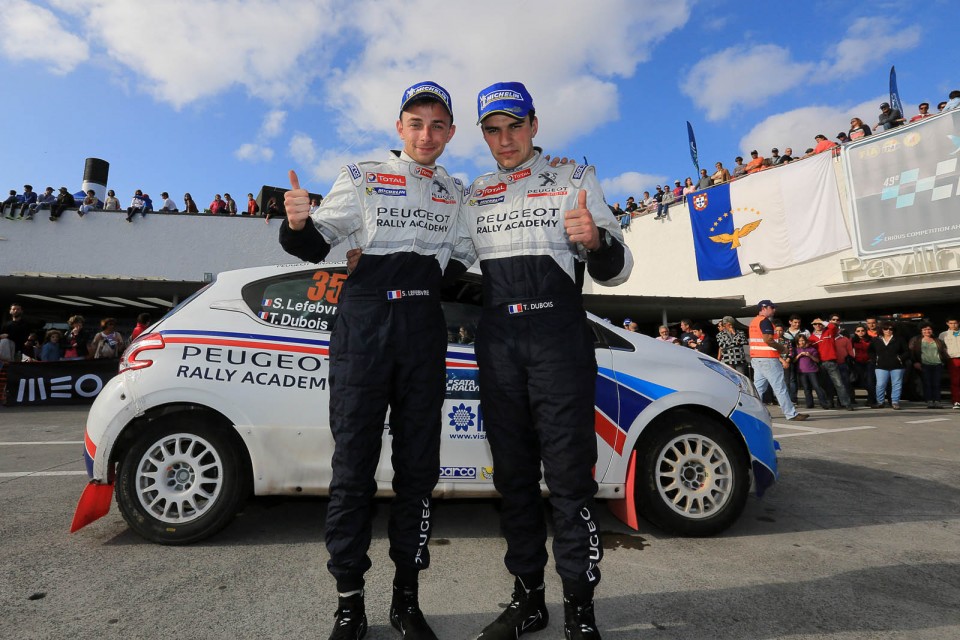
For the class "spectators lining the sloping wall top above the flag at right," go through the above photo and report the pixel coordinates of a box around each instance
[611,90,960,229]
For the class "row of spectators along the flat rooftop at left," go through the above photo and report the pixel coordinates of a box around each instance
[0,184,308,223]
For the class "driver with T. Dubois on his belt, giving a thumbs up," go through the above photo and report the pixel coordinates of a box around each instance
[446,82,633,640]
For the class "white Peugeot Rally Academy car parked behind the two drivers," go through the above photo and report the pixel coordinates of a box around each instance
[71,264,777,544]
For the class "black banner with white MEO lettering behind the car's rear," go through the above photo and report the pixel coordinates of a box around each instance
[4,359,119,407]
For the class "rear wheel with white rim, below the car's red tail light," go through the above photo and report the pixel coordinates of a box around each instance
[116,416,249,545]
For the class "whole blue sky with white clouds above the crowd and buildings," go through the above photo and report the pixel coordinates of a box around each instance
[0,0,960,207]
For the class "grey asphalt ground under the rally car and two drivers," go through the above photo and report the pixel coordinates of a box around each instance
[0,403,960,640]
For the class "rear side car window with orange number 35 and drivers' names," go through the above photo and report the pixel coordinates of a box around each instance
[243,267,347,331]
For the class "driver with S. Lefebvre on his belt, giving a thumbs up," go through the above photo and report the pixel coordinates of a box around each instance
[280,82,463,640]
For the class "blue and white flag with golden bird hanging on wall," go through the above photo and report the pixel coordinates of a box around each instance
[687,153,850,280]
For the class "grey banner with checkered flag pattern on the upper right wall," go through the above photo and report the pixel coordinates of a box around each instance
[843,110,960,256]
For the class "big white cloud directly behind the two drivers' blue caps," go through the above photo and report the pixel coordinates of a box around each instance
[326,0,691,166]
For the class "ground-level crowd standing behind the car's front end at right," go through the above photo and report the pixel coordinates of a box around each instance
[623,313,960,410]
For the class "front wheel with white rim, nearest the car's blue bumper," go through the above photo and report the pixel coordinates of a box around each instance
[634,411,750,537]
